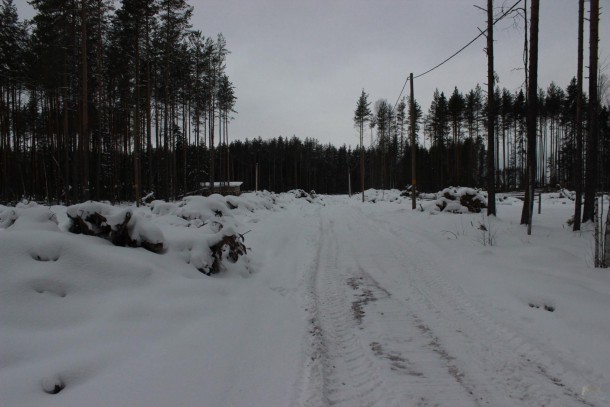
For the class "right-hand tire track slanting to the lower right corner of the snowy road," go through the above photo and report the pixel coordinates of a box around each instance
[356,209,594,407]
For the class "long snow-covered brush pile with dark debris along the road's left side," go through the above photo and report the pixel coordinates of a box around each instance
[0,191,276,276]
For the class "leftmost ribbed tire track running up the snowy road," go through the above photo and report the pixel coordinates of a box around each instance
[298,213,387,407]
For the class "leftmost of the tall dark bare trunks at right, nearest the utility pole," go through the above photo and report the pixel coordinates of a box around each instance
[487,0,496,216]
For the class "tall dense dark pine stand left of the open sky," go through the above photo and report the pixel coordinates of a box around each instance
[0,0,236,202]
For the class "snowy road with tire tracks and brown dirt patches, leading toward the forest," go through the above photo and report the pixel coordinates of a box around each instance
[252,202,591,407]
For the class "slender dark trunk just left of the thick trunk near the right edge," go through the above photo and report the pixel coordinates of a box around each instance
[573,0,585,231]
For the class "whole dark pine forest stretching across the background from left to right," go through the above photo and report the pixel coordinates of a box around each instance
[0,0,610,207]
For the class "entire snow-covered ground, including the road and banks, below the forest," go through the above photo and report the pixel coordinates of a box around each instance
[0,190,610,407]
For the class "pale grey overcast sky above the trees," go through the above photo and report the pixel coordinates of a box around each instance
[16,0,610,150]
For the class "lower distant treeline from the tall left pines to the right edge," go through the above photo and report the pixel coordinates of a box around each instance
[229,76,610,193]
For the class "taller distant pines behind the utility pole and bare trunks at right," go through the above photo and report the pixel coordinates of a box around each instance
[355,79,610,197]
